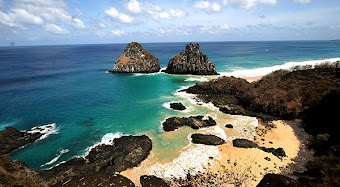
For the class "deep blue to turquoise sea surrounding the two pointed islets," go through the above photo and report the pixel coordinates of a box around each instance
[0,41,340,169]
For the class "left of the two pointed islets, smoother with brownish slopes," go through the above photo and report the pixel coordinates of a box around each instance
[109,42,160,73]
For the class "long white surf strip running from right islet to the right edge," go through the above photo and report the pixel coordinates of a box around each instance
[220,58,340,77]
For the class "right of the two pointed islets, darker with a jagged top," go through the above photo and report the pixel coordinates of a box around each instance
[165,43,217,75]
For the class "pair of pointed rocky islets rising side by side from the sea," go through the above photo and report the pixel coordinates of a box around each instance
[109,42,217,75]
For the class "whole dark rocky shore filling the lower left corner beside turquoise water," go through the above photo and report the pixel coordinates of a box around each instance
[0,128,152,186]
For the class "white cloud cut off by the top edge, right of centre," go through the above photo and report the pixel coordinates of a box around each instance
[223,0,277,9]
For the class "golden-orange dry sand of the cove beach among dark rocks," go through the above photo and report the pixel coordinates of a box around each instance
[121,117,301,186]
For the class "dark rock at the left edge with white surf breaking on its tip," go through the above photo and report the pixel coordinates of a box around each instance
[0,127,47,154]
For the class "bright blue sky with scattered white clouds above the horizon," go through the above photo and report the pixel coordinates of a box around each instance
[0,0,340,46]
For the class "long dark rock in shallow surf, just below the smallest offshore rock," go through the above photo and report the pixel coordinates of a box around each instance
[163,116,216,131]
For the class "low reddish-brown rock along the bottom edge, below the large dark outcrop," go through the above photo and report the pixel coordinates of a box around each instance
[51,173,135,187]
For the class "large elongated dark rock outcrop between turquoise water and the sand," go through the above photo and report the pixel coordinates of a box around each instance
[39,135,152,180]
